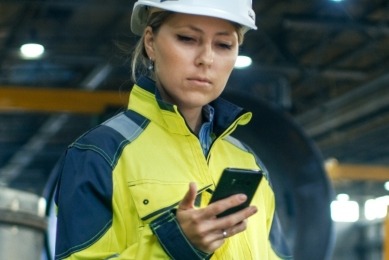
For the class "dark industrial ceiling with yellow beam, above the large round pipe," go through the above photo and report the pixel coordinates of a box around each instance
[0,0,389,200]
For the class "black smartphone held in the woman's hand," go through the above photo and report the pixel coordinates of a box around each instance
[209,168,263,217]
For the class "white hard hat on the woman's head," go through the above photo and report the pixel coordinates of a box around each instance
[131,0,257,35]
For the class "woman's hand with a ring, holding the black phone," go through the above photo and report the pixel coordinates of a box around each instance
[176,182,257,253]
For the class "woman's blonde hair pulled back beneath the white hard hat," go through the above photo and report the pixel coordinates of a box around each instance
[131,10,245,82]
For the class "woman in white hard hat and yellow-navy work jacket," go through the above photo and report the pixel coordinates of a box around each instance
[56,0,292,259]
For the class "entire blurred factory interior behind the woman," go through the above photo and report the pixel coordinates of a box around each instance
[0,0,389,260]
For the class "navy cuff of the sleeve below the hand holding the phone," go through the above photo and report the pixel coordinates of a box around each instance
[150,210,212,259]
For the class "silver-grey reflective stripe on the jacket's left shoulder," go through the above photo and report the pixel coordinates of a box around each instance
[103,113,143,142]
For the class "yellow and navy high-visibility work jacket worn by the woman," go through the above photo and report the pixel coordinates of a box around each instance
[55,78,292,260]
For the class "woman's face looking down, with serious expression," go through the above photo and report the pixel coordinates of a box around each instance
[145,14,239,110]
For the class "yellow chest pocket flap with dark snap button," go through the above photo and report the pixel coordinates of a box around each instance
[128,180,211,223]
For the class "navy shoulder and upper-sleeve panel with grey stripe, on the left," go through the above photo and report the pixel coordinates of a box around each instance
[54,111,149,259]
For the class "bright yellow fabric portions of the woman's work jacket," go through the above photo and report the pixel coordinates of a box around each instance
[59,76,278,260]
